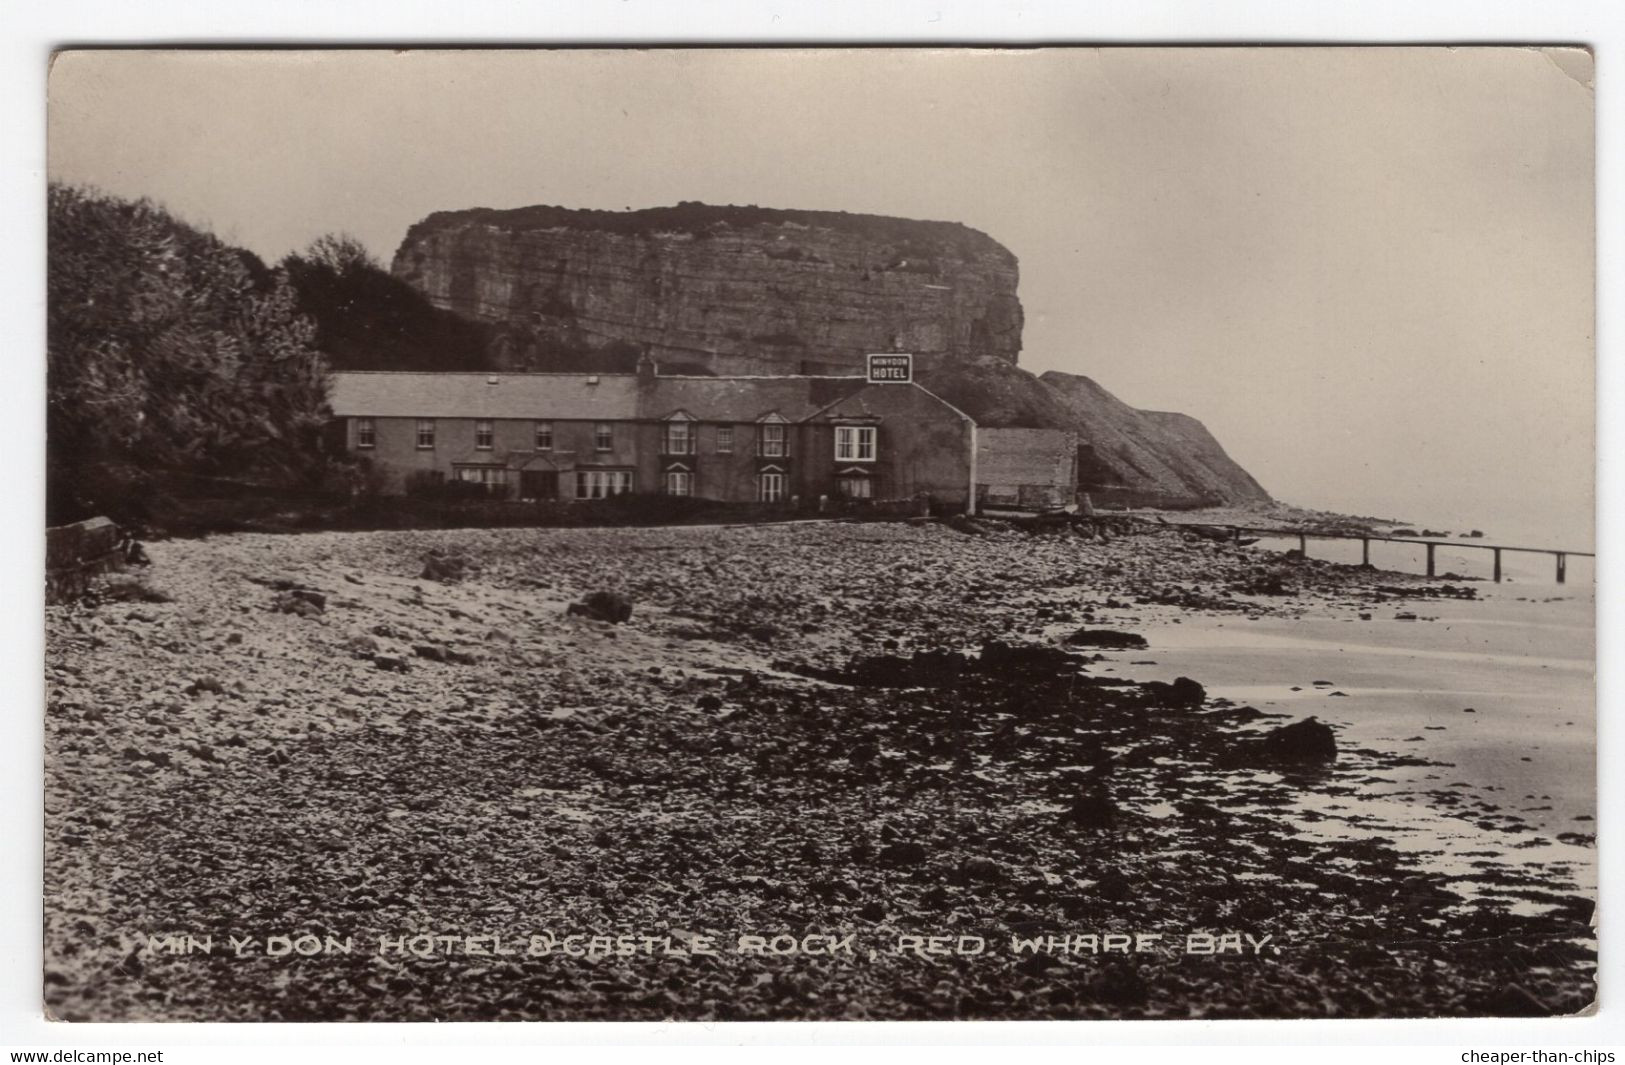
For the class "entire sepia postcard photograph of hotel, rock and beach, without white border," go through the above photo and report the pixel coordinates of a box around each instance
[41,44,1599,1023]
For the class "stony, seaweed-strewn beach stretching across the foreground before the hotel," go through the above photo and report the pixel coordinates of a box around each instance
[47,524,1594,1019]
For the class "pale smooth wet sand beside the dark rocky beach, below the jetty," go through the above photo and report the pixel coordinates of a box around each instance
[1103,582,1597,910]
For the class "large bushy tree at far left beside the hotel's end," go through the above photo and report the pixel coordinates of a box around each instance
[46,184,327,519]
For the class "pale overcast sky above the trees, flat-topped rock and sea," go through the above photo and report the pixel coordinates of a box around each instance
[49,49,1594,546]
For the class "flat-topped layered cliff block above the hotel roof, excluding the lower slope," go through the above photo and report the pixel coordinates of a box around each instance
[393,203,1022,374]
